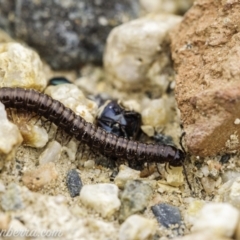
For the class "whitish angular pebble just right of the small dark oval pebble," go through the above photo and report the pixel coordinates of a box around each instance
[80,183,121,218]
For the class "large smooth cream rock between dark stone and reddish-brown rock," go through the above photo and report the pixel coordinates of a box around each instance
[104,14,182,92]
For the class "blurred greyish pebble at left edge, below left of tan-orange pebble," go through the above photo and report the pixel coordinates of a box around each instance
[0,183,24,211]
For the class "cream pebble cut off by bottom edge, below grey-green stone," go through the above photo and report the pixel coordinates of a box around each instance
[119,215,156,240]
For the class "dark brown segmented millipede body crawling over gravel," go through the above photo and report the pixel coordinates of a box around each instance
[0,87,185,166]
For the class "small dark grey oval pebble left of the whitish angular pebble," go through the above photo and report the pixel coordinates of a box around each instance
[67,169,83,198]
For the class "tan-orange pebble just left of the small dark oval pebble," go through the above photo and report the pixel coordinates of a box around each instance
[22,162,58,191]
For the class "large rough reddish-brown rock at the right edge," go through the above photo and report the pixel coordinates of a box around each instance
[171,0,240,156]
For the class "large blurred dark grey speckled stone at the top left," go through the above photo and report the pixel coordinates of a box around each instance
[0,0,139,69]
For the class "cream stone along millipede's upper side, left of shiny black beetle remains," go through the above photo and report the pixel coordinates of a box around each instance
[45,84,98,123]
